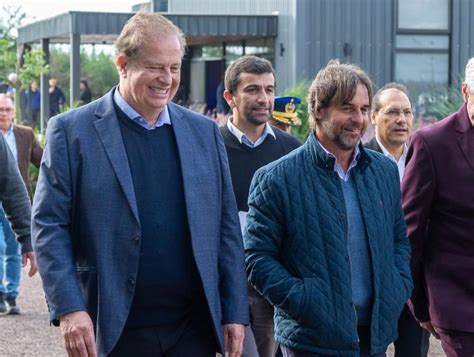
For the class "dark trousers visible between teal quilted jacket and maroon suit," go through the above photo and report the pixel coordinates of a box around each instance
[394,305,430,357]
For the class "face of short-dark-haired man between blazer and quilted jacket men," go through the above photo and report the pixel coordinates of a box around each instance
[224,73,275,132]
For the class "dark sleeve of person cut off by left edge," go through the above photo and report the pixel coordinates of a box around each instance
[0,134,32,254]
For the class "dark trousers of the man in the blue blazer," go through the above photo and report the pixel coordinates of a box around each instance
[109,310,217,357]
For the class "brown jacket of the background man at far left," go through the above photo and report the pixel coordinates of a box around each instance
[13,124,43,199]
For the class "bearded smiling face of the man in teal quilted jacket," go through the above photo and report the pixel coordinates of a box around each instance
[313,84,370,157]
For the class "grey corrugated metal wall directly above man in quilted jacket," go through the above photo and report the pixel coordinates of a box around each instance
[296,0,394,86]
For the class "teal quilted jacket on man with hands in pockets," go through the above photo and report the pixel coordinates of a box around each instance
[244,135,412,356]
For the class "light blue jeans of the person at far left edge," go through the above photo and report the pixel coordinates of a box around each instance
[0,208,21,299]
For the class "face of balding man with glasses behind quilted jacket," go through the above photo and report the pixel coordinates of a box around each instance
[371,88,413,149]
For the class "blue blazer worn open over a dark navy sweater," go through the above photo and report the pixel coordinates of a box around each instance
[32,89,248,356]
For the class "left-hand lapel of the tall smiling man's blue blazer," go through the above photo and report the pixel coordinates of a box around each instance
[94,90,140,222]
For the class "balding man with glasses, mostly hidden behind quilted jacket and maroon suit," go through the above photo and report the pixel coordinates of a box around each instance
[365,82,429,357]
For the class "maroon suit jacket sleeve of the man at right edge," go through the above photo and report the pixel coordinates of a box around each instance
[402,133,436,321]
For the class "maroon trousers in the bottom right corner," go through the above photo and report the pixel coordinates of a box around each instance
[437,328,474,357]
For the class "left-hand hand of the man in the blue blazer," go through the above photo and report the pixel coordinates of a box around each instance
[59,311,97,357]
